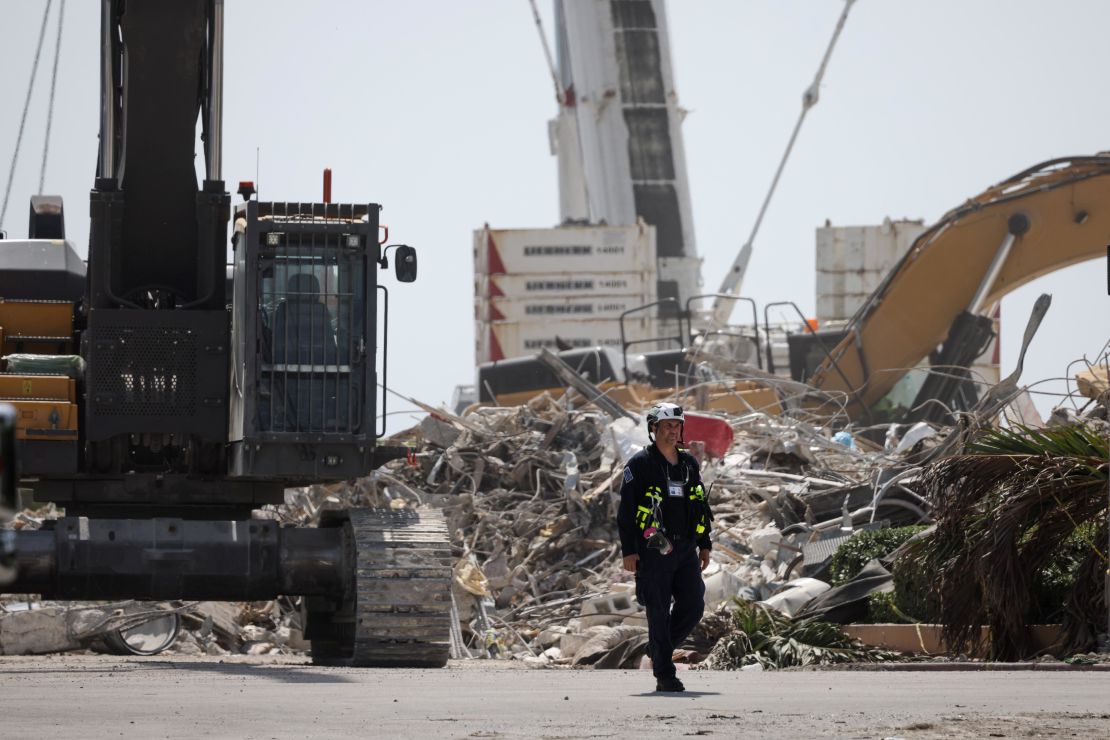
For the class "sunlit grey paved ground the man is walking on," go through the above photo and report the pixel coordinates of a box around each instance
[0,656,1110,740]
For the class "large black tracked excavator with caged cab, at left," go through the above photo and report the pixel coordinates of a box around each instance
[0,0,451,667]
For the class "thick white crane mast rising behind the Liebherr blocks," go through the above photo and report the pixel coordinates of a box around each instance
[551,0,700,315]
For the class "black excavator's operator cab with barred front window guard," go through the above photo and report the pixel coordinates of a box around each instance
[229,201,380,480]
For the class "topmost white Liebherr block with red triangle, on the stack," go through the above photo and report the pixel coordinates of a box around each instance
[474,224,656,276]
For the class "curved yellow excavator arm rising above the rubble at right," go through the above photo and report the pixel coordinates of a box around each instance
[811,155,1110,418]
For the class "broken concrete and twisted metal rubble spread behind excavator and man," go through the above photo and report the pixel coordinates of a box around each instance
[0,348,1106,670]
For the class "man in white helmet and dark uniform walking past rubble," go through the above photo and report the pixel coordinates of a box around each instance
[617,403,713,691]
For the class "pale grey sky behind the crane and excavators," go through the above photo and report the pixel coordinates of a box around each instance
[0,0,1110,429]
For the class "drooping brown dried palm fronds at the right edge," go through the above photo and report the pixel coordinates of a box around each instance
[918,425,1108,659]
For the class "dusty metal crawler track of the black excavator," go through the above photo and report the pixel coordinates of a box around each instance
[312,508,452,668]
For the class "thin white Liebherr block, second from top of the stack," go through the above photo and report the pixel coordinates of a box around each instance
[474,272,655,303]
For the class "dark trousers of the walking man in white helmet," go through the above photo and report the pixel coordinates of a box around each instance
[636,540,705,678]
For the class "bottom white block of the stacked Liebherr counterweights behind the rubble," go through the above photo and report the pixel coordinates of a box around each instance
[475,318,677,365]
